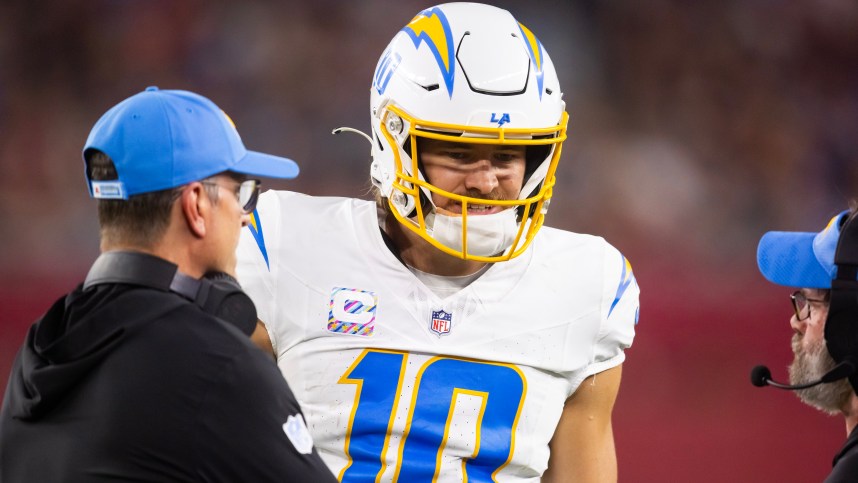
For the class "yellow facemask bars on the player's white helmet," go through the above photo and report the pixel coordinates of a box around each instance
[379,104,568,262]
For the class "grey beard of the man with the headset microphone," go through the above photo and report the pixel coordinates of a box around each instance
[789,334,852,414]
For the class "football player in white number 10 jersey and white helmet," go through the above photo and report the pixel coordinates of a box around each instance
[238,3,639,482]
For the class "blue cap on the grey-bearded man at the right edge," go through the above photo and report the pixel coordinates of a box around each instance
[757,210,849,288]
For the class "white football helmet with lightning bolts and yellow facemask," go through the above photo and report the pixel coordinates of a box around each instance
[370,3,568,262]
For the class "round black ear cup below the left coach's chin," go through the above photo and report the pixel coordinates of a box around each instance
[197,273,257,336]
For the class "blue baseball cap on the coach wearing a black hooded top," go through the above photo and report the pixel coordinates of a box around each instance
[83,87,298,199]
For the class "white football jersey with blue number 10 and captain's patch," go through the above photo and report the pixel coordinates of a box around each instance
[238,191,639,482]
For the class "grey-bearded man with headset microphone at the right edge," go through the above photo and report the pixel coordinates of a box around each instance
[751,210,858,483]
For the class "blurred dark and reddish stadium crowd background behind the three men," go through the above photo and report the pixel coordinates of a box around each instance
[0,0,858,482]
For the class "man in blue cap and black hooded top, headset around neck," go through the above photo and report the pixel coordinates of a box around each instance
[0,87,336,483]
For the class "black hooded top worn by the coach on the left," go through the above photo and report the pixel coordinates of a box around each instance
[0,284,336,483]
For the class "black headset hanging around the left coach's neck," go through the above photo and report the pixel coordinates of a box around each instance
[83,251,257,336]
